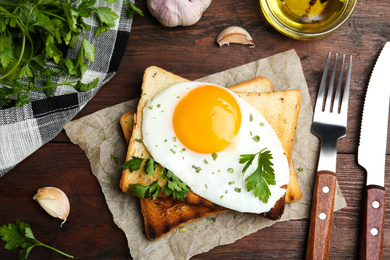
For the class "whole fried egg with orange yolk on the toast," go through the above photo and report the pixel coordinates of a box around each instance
[142,82,290,213]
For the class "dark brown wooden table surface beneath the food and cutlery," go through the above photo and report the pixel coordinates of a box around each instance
[0,0,390,259]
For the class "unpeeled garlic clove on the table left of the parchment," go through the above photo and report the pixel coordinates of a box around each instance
[33,187,70,226]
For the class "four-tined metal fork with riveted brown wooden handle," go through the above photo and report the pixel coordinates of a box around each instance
[306,53,352,259]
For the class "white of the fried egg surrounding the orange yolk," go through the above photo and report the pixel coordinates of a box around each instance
[142,82,290,213]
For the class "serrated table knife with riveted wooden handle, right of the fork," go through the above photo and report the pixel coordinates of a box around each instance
[358,42,390,259]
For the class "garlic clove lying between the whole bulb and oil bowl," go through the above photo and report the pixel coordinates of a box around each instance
[216,26,255,47]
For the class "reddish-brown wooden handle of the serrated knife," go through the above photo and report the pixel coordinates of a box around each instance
[360,185,385,259]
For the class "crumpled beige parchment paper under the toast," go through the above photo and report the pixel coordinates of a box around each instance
[65,50,346,260]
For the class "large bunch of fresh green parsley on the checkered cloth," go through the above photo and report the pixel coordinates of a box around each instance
[0,0,142,107]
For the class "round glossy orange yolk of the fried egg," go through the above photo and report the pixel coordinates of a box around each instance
[172,85,241,153]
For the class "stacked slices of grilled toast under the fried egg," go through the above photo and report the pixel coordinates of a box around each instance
[120,67,302,240]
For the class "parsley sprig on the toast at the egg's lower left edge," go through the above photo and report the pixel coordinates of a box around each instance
[122,156,190,199]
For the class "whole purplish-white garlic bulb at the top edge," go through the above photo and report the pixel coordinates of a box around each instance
[148,0,211,27]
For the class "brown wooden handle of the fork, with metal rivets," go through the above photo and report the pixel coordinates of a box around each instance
[306,171,336,259]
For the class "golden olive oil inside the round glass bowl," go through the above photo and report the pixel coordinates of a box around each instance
[268,0,347,32]
